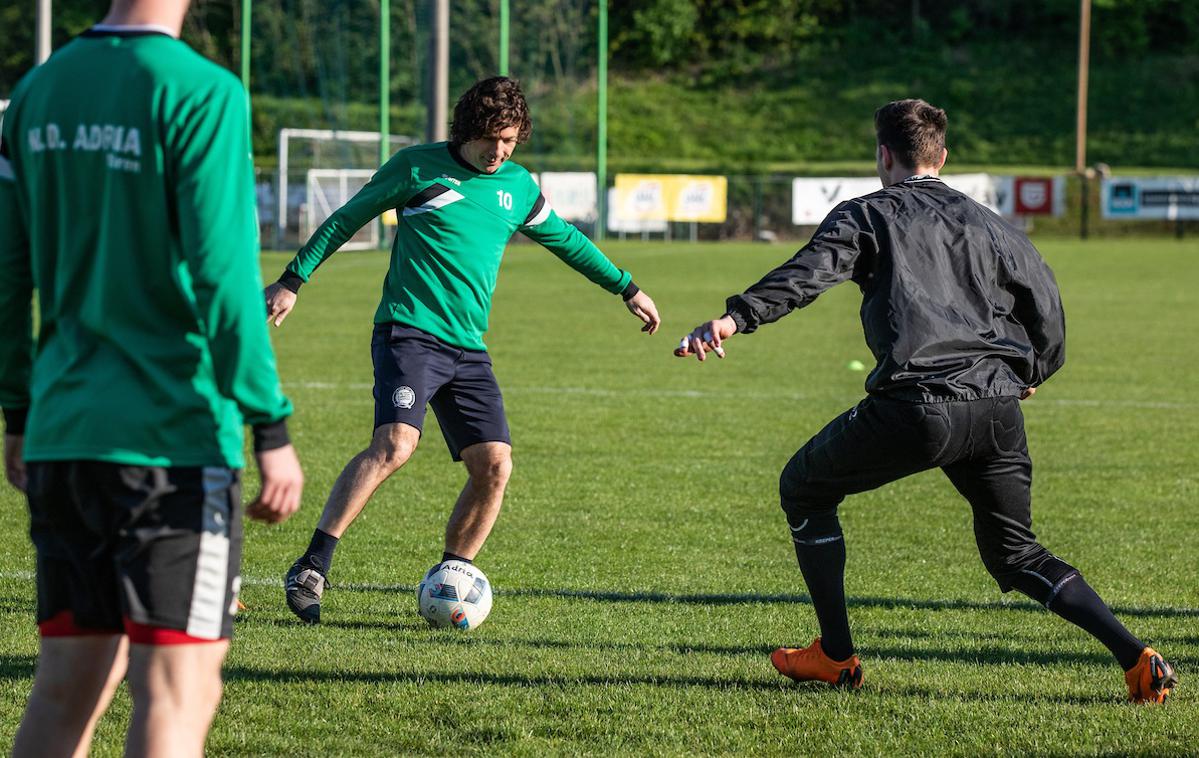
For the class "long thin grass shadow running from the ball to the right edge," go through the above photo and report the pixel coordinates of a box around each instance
[321,584,1199,618]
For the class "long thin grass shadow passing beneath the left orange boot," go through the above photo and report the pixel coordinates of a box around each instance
[225,666,1120,705]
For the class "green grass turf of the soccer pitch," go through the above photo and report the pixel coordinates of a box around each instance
[0,241,1199,756]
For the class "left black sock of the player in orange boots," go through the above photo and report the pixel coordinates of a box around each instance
[791,513,854,661]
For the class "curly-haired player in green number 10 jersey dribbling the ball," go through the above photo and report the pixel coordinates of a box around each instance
[266,77,659,624]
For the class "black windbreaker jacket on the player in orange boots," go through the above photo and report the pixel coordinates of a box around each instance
[727,176,1066,403]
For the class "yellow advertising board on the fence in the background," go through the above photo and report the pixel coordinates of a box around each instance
[615,174,729,223]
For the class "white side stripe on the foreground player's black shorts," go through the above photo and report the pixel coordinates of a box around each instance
[187,467,233,639]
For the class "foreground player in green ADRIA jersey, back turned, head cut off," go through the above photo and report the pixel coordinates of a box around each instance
[0,0,302,756]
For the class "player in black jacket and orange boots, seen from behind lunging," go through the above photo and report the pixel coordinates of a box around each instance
[675,101,1176,702]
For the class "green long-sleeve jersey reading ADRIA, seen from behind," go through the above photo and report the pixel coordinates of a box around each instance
[0,28,291,468]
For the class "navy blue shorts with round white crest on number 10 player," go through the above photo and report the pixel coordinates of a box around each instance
[370,324,512,461]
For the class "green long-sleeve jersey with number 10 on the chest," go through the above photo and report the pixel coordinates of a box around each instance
[282,143,631,350]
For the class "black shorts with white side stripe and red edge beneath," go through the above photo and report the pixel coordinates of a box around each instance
[26,461,242,640]
